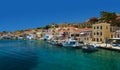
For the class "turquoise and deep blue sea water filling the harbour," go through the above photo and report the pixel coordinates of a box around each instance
[0,40,120,70]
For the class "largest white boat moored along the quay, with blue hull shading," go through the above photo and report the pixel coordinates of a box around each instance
[62,40,82,47]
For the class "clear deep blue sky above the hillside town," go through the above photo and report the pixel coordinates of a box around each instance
[0,0,120,32]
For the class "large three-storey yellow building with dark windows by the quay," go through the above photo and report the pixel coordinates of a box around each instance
[92,23,111,42]
